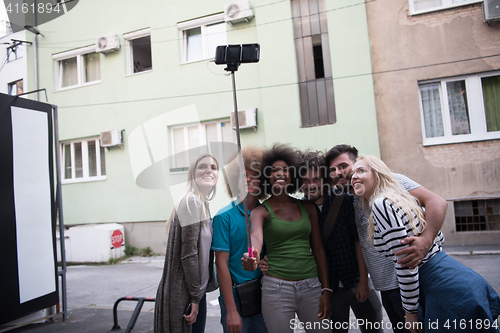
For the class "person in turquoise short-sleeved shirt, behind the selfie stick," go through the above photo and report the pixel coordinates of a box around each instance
[212,147,267,333]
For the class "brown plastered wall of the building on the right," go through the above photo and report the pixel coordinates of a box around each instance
[367,0,500,244]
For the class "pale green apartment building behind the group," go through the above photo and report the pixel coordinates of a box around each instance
[25,0,380,252]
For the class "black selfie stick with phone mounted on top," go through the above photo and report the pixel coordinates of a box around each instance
[215,44,260,258]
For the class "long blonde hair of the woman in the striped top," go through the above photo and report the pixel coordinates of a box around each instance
[356,155,426,240]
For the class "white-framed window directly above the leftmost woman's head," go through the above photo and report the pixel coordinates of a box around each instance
[170,119,235,172]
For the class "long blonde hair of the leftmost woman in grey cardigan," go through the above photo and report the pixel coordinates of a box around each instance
[166,154,219,236]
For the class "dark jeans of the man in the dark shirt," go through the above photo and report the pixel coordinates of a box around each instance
[330,281,383,333]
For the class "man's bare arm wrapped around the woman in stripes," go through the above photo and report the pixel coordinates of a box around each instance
[397,186,448,268]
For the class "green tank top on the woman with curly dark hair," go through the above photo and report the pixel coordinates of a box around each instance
[263,200,318,280]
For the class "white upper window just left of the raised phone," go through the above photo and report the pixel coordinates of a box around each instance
[177,14,227,63]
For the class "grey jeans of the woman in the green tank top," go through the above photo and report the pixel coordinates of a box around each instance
[262,275,331,333]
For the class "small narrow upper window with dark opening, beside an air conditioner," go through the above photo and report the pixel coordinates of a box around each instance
[123,29,153,74]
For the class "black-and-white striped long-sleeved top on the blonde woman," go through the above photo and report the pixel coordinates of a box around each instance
[372,197,443,313]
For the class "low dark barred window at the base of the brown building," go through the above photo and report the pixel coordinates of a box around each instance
[454,199,500,231]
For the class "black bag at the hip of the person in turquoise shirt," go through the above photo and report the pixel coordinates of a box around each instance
[234,278,262,318]
